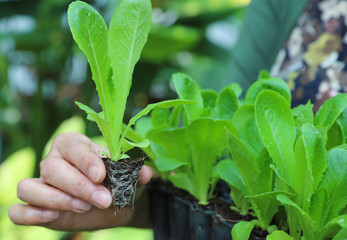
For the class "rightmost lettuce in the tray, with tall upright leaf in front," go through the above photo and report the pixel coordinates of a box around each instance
[255,90,347,240]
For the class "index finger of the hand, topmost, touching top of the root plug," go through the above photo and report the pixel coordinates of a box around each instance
[50,133,106,183]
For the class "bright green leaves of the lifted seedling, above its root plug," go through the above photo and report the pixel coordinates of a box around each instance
[68,0,187,161]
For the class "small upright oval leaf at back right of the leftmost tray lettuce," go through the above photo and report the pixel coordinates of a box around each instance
[216,86,239,121]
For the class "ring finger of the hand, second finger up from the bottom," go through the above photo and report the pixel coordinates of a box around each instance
[17,178,91,213]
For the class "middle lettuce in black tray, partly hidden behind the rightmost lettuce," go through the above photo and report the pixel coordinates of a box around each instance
[217,75,291,234]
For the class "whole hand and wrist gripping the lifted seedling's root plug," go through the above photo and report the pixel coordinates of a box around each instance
[9,133,152,231]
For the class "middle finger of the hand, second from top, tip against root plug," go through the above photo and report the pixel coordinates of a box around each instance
[41,157,112,208]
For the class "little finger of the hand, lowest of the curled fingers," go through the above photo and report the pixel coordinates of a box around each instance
[8,204,59,225]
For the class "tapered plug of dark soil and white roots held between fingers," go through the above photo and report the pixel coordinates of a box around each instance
[103,158,144,214]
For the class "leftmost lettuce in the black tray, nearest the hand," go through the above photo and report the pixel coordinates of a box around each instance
[135,73,240,204]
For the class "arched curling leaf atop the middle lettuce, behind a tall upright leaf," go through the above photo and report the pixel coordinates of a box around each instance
[245,78,292,105]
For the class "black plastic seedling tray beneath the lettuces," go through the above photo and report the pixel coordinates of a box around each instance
[147,181,266,240]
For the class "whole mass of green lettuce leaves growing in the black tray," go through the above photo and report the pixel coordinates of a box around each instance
[135,72,347,239]
